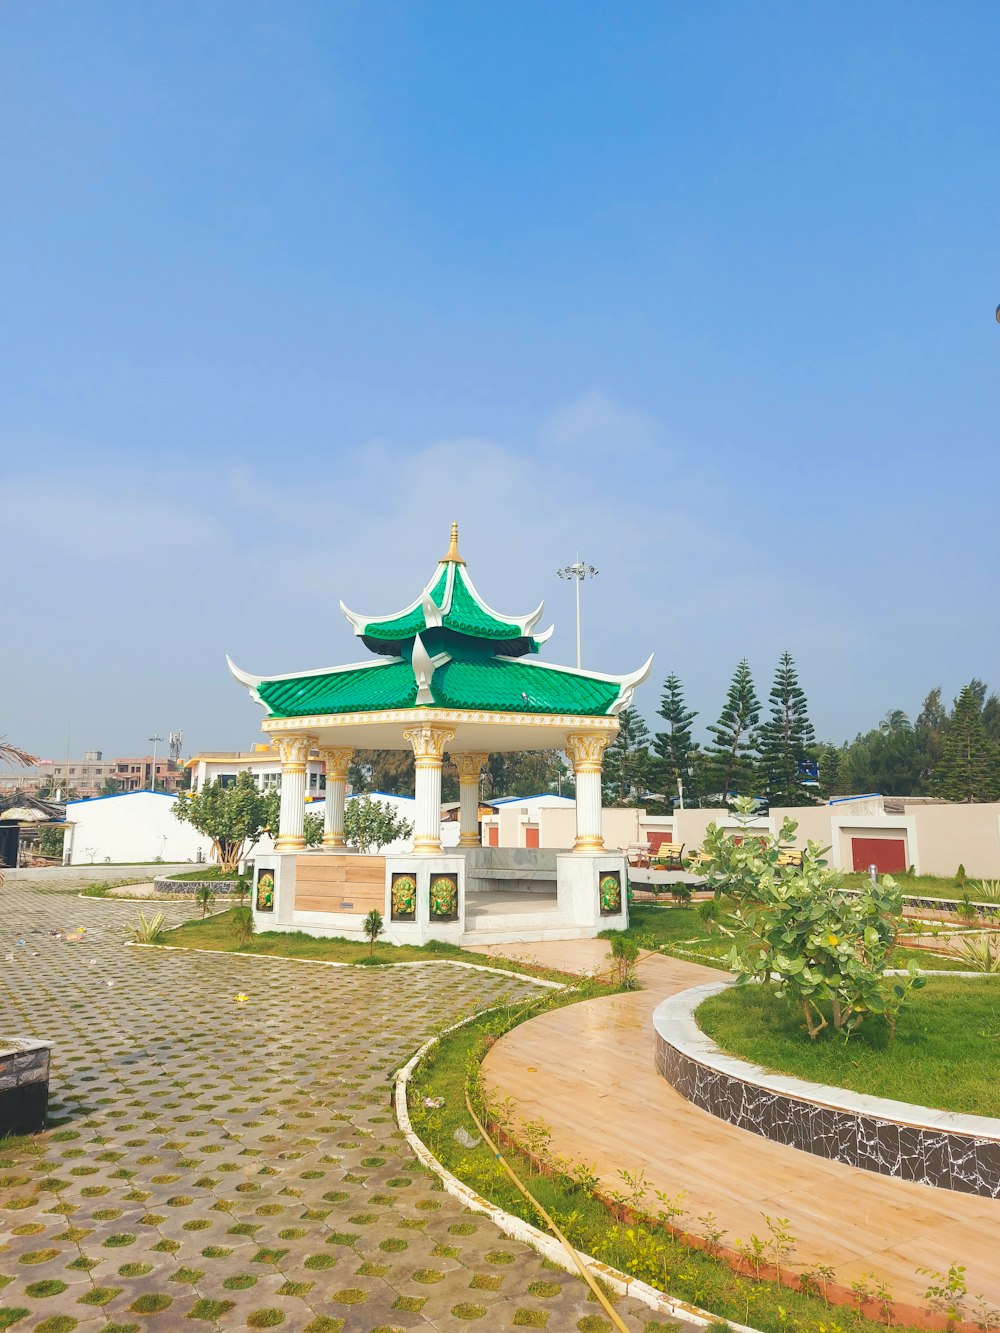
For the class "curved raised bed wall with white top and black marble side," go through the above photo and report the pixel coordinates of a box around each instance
[653,980,1000,1198]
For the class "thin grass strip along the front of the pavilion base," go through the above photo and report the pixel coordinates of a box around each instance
[160,912,576,982]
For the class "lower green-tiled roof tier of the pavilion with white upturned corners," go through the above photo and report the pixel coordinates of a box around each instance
[229,636,652,718]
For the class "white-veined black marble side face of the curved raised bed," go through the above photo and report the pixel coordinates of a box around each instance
[656,1002,1000,1198]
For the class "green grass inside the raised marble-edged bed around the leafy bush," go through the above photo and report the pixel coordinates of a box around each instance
[697,977,1000,1116]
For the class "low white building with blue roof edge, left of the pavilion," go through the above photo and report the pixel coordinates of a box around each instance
[63,792,212,865]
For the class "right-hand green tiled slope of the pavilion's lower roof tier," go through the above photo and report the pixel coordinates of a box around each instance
[431,657,621,717]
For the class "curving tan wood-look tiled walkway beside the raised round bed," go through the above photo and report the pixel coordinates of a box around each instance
[474,940,1000,1305]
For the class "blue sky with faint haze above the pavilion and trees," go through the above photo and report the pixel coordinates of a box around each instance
[0,0,1000,756]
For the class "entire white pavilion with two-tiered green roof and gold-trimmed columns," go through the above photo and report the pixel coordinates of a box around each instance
[229,524,652,942]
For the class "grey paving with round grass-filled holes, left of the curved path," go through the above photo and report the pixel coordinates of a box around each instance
[0,878,677,1333]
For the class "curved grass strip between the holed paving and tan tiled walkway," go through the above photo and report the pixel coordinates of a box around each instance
[409,985,928,1333]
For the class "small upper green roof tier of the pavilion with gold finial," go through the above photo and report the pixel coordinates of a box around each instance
[340,524,552,655]
